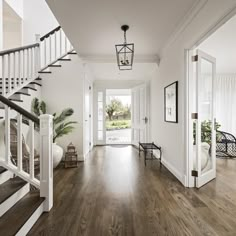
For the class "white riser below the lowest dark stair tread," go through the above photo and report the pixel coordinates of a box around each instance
[16,202,44,236]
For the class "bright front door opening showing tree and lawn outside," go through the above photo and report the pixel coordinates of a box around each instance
[106,89,132,144]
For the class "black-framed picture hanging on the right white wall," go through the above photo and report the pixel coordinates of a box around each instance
[164,81,178,123]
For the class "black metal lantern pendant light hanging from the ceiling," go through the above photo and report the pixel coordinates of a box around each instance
[116,25,134,70]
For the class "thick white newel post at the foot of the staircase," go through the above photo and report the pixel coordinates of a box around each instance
[39,115,53,211]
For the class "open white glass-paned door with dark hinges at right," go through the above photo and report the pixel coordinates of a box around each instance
[195,50,216,188]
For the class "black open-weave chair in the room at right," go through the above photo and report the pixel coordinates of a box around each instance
[216,130,236,158]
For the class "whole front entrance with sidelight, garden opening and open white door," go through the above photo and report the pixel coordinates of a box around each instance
[93,83,150,146]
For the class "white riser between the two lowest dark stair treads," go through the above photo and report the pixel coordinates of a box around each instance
[0,184,30,217]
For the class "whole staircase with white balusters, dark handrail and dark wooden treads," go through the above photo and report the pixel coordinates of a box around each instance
[0,26,76,236]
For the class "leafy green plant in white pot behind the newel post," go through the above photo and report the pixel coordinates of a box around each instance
[31,98,77,168]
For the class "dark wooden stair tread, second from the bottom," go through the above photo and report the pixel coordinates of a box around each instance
[0,177,27,205]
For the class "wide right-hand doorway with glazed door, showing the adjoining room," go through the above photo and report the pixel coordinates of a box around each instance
[186,12,236,188]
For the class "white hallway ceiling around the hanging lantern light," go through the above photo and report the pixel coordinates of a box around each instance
[47,0,195,80]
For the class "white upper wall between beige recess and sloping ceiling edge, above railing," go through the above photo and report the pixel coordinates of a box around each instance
[23,0,59,45]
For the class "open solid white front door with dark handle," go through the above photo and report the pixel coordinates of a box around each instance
[132,84,149,146]
